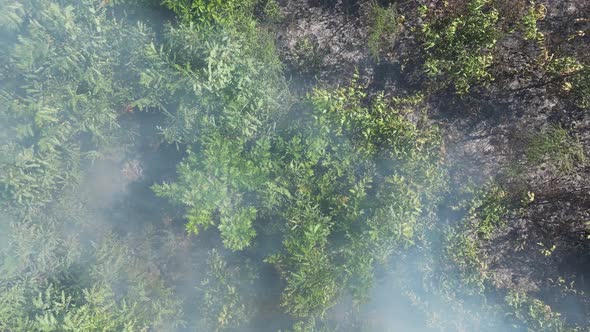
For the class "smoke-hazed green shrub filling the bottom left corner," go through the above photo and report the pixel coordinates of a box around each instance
[0,215,183,331]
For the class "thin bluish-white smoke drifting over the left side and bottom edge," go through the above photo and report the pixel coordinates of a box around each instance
[0,0,588,332]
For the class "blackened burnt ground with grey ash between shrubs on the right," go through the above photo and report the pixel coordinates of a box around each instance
[277,0,590,322]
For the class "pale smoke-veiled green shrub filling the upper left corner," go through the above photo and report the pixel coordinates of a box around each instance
[0,0,152,212]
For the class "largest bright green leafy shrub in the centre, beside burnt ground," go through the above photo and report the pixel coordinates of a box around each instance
[154,75,444,321]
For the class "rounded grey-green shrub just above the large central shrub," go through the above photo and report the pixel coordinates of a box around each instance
[139,24,285,145]
